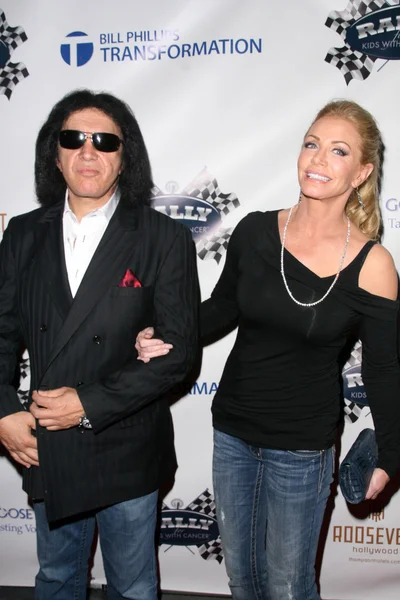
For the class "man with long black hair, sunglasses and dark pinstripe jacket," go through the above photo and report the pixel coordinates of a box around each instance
[0,90,198,600]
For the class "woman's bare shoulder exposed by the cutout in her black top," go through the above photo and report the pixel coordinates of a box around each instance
[358,244,398,300]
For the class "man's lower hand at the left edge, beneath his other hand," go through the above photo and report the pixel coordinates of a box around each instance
[0,411,39,469]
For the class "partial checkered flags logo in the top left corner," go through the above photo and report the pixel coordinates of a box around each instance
[0,9,29,99]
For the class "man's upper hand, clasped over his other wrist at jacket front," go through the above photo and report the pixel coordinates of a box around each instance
[30,387,85,431]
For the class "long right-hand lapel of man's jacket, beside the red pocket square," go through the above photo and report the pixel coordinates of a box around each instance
[46,202,140,370]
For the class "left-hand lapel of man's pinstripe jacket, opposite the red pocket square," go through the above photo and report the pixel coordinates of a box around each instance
[34,204,72,319]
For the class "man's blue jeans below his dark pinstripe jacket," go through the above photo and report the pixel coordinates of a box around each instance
[34,491,158,600]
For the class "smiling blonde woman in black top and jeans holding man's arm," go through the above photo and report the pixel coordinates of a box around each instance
[137,101,400,600]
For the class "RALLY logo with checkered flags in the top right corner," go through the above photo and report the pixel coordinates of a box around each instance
[325,0,400,85]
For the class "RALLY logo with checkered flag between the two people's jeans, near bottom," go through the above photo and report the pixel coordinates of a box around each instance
[158,489,224,564]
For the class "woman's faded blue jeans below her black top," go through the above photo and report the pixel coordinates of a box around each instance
[213,430,334,600]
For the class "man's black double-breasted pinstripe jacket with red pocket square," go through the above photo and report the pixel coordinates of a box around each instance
[0,199,198,521]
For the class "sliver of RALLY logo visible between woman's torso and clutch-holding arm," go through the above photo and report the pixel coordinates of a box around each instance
[342,342,368,423]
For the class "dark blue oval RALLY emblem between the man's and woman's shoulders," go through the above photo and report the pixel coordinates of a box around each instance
[152,194,221,242]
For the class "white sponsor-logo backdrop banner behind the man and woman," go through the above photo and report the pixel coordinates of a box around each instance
[0,0,400,600]
